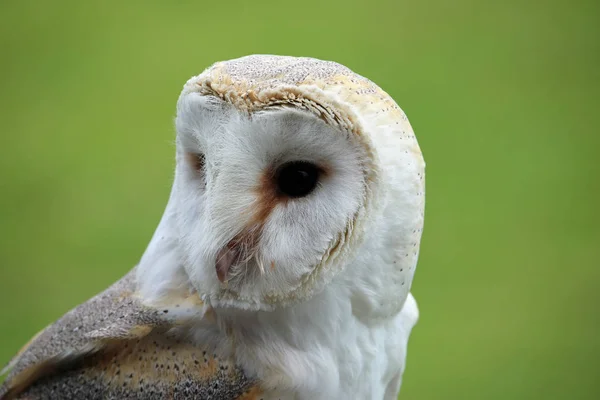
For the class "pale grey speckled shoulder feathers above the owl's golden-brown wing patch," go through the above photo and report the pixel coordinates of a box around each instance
[0,268,166,400]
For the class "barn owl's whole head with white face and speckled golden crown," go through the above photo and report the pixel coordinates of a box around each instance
[138,55,424,312]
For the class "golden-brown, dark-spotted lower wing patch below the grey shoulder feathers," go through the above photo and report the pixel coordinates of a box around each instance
[15,332,256,400]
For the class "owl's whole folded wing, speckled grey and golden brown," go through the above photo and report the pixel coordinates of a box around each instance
[0,270,261,400]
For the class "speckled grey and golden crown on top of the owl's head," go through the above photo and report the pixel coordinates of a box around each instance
[190,55,422,157]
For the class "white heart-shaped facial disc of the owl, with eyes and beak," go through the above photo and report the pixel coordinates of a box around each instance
[174,93,366,308]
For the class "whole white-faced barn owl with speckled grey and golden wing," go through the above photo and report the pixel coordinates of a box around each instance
[0,55,425,400]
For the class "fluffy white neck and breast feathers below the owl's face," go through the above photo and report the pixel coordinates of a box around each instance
[196,245,418,400]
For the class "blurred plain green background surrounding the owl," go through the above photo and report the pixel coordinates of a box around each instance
[0,0,600,399]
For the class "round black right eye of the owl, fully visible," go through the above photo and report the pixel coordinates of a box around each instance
[276,161,319,197]
